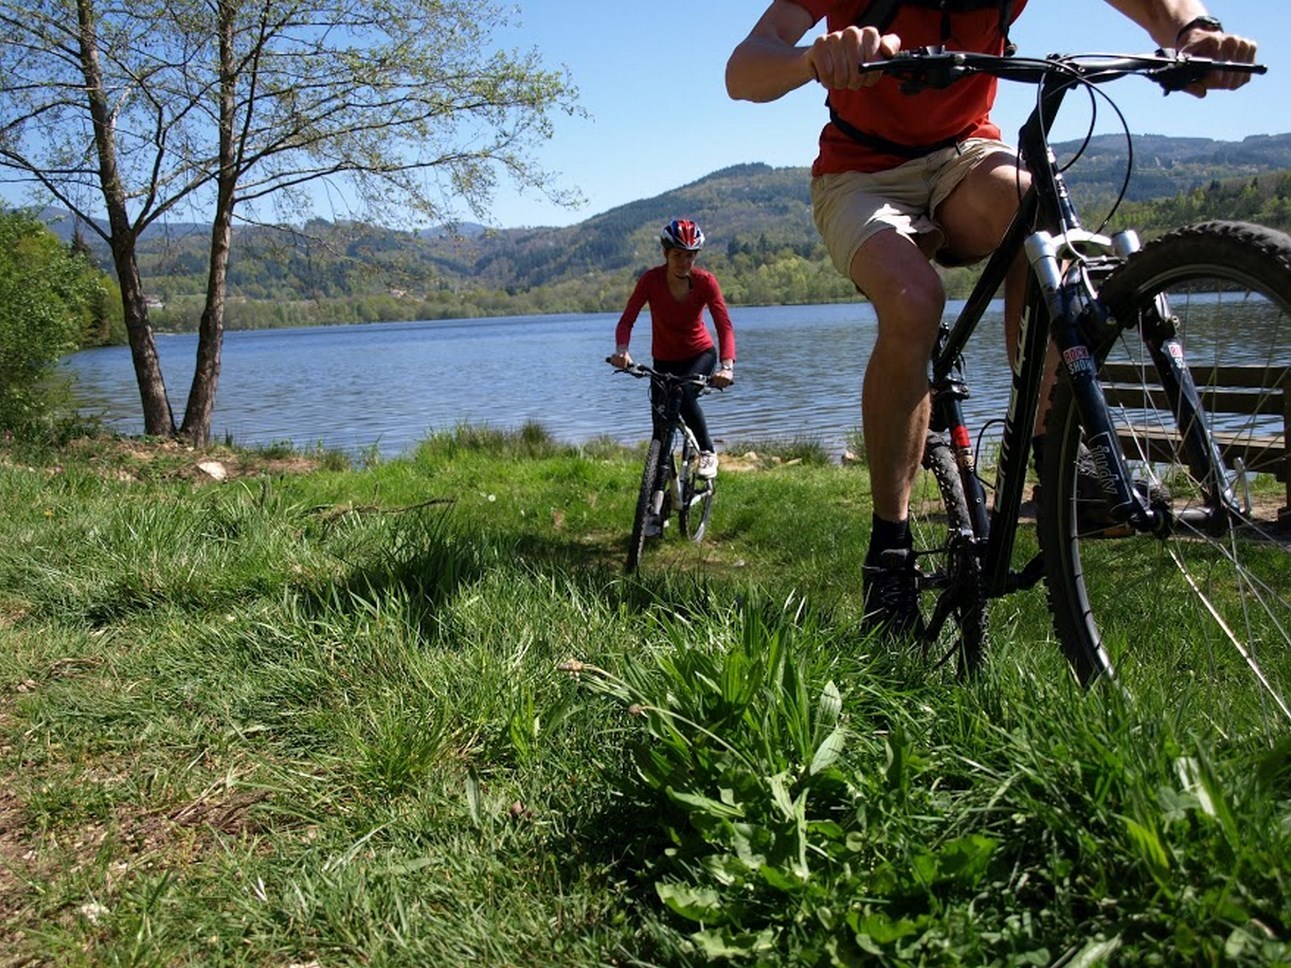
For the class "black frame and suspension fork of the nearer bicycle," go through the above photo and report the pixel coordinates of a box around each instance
[931,58,1237,598]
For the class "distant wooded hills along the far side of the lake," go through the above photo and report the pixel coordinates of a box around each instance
[27,134,1291,299]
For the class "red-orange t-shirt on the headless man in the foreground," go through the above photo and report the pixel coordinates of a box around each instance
[794,0,1026,174]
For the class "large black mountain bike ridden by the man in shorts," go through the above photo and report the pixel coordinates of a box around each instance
[862,48,1291,728]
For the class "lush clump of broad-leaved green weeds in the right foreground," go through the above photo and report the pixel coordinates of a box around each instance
[565,609,1291,965]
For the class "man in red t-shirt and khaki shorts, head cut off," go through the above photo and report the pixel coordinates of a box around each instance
[726,0,1255,636]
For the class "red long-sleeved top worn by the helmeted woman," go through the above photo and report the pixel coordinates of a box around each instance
[615,265,735,363]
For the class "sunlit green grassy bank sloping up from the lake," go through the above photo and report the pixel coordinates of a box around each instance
[0,429,1291,965]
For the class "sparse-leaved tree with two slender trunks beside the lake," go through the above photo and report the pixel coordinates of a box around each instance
[0,0,577,444]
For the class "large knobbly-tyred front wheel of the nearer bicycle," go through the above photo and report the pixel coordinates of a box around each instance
[1038,222,1291,734]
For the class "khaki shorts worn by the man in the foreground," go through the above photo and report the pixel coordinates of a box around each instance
[811,138,1016,277]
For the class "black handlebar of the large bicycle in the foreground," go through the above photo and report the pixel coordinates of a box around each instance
[861,46,1268,94]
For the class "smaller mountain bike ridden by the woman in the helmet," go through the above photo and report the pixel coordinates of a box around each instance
[605,359,717,573]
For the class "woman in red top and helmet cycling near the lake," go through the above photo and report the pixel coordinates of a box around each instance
[609,218,735,479]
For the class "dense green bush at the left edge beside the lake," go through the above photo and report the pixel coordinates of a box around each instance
[0,210,106,436]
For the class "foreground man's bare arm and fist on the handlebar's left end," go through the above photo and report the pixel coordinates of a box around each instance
[726,0,901,101]
